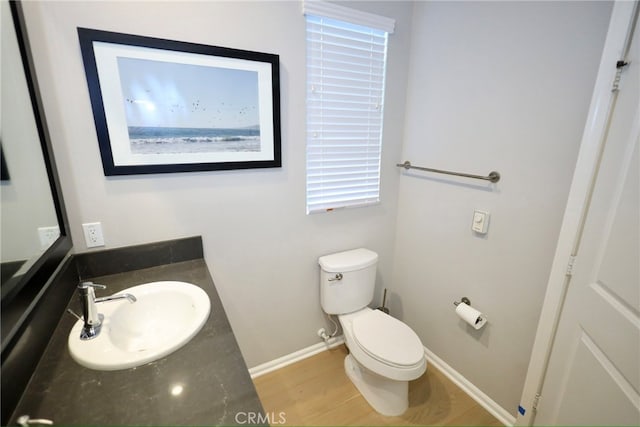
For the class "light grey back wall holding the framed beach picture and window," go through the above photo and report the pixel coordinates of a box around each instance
[24,1,412,366]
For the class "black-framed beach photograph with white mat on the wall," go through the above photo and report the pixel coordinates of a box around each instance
[78,28,282,175]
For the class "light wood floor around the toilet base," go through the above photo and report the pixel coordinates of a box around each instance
[253,345,502,426]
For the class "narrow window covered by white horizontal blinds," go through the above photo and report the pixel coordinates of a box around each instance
[304,1,394,213]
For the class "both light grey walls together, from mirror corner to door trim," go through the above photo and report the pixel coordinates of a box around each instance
[18,1,610,413]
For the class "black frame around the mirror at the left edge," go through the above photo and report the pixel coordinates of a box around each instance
[1,0,72,372]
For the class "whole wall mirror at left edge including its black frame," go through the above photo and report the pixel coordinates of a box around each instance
[0,0,71,352]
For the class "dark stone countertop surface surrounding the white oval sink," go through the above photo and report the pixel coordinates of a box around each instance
[12,259,264,425]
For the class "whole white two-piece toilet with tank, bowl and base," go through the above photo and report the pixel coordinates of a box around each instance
[318,248,427,416]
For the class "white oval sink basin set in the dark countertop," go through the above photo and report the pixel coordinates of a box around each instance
[69,281,211,371]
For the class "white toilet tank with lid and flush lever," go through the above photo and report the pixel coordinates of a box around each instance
[318,248,378,314]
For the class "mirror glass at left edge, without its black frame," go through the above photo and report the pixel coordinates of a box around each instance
[0,2,60,296]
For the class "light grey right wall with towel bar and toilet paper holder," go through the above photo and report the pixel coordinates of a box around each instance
[390,2,613,415]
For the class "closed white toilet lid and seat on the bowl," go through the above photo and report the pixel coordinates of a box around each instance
[352,310,424,368]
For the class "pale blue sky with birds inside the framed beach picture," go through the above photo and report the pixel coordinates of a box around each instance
[118,57,260,128]
